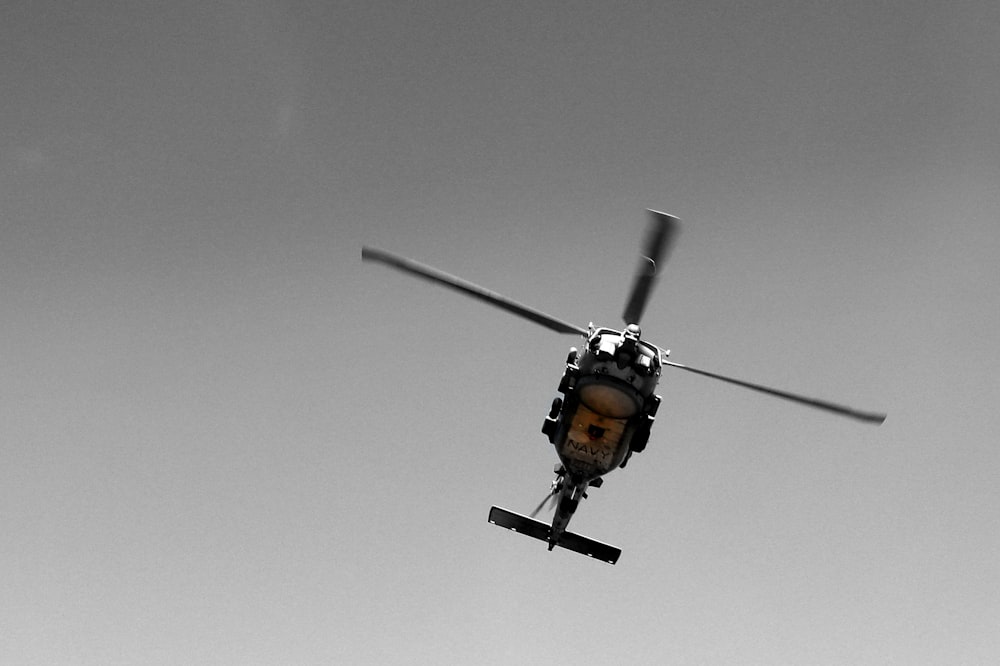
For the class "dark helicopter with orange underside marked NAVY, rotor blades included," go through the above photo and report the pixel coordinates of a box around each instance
[361,210,886,564]
